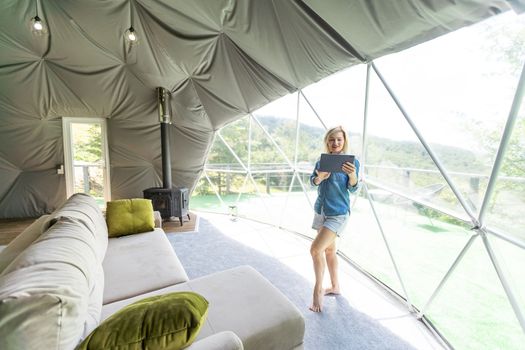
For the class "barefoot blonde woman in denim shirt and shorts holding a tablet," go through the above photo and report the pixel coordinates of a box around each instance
[310,126,359,312]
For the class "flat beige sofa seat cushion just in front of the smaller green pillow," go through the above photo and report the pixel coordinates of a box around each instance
[103,229,188,304]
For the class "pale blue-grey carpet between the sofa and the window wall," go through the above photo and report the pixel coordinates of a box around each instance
[168,218,414,350]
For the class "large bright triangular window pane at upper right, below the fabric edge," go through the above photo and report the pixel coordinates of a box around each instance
[370,11,524,216]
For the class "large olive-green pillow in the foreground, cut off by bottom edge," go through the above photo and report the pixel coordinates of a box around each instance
[77,292,208,350]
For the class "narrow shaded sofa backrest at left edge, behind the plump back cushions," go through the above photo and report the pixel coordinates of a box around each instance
[0,215,49,275]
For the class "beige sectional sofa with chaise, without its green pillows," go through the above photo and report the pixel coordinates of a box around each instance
[0,194,305,350]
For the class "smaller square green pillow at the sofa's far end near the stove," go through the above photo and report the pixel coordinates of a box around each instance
[106,198,155,237]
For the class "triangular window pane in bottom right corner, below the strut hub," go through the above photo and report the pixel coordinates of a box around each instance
[426,237,525,350]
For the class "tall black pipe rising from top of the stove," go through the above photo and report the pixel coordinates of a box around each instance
[157,87,172,188]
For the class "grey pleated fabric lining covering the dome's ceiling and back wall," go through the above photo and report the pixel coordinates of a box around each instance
[0,0,523,217]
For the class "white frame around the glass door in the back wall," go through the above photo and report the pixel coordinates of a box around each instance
[62,117,111,202]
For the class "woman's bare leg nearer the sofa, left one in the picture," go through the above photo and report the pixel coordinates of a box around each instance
[310,226,336,312]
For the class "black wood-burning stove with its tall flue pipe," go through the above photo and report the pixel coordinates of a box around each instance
[143,87,190,226]
